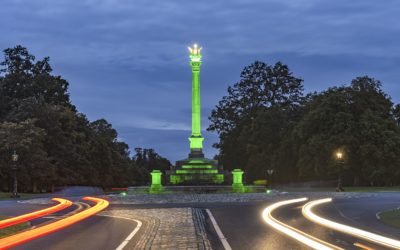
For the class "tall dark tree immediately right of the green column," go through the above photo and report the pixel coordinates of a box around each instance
[208,61,303,180]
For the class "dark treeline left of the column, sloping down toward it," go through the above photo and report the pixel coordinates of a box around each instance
[0,46,170,192]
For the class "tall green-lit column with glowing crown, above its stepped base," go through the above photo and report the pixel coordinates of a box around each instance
[189,44,204,154]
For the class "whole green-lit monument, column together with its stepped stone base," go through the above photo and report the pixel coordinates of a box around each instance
[168,44,224,185]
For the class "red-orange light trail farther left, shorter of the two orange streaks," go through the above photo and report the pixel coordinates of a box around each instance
[0,198,72,229]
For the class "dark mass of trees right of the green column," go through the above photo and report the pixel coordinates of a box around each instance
[208,61,400,185]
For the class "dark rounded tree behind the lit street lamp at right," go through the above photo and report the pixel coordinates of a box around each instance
[294,76,400,185]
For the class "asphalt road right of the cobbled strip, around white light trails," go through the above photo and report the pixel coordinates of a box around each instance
[206,194,400,250]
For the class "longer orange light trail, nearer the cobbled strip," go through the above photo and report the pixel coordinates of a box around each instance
[0,197,109,249]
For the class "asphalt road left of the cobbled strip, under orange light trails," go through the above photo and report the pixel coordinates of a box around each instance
[0,198,141,250]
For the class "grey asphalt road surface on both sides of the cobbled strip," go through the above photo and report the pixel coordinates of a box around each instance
[0,193,400,250]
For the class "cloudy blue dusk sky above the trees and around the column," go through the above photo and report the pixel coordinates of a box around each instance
[0,0,400,161]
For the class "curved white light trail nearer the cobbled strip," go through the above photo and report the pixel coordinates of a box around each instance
[262,198,342,250]
